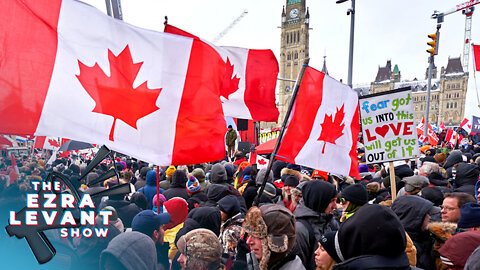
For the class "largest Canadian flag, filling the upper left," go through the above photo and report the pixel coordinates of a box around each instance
[0,0,226,165]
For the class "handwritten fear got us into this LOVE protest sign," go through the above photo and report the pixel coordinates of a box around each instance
[359,88,418,164]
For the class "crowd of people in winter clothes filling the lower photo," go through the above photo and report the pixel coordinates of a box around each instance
[0,139,480,270]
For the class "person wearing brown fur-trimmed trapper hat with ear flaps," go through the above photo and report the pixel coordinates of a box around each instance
[243,204,305,270]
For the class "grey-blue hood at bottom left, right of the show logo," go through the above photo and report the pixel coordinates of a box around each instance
[100,232,157,270]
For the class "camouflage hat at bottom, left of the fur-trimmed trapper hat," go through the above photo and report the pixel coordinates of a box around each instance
[177,229,222,262]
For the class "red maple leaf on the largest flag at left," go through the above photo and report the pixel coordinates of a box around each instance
[77,45,162,141]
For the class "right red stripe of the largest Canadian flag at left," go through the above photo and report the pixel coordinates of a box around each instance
[172,40,227,165]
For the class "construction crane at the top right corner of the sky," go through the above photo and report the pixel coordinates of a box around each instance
[432,0,480,72]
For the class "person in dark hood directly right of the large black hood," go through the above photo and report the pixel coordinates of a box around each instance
[392,195,435,270]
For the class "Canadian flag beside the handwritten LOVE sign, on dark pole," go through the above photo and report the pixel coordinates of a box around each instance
[277,67,360,177]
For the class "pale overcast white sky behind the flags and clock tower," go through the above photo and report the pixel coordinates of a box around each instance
[84,0,480,119]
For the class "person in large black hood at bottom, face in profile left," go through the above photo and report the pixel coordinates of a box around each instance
[315,204,412,270]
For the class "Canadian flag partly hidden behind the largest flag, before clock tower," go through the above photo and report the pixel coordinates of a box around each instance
[164,24,279,122]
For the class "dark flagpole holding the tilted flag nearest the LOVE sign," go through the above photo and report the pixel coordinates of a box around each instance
[253,58,310,206]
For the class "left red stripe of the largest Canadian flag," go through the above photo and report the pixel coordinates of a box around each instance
[0,0,62,135]
